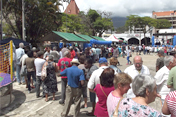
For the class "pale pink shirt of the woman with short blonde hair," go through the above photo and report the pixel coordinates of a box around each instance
[106,92,120,117]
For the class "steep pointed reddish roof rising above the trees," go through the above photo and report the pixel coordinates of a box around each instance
[64,0,79,15]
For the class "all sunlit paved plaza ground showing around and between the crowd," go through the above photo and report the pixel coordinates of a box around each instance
[0,53,161,117]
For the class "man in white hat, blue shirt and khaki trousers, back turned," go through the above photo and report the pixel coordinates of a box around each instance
[60,59,85,117]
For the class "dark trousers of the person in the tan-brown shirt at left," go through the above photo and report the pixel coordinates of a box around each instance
[27,71,36,91]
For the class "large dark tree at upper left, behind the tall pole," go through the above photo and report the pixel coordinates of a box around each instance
[3,0,61,45]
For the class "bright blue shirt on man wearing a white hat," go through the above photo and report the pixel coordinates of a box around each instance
[60,66,85,88]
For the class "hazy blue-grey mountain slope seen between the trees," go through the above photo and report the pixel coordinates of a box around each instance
[111,17,127,29]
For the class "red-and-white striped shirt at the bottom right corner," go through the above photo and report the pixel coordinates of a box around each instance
[165,91,176,117]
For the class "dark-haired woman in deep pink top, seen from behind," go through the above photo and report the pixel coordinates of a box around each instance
[94,68,114,117]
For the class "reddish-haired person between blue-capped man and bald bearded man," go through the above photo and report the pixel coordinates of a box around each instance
[109,57,121,74]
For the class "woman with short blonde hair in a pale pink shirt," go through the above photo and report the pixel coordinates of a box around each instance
[106,72,132,117]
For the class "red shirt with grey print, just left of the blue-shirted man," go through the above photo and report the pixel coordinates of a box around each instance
[57,58,72,78]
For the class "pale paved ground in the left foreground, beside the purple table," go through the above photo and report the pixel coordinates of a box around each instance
[0,77,95,117]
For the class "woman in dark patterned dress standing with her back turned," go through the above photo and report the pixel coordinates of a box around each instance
[43,55,58,102]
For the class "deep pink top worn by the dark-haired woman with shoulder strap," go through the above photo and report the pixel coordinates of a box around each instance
[94,84,114,117]
